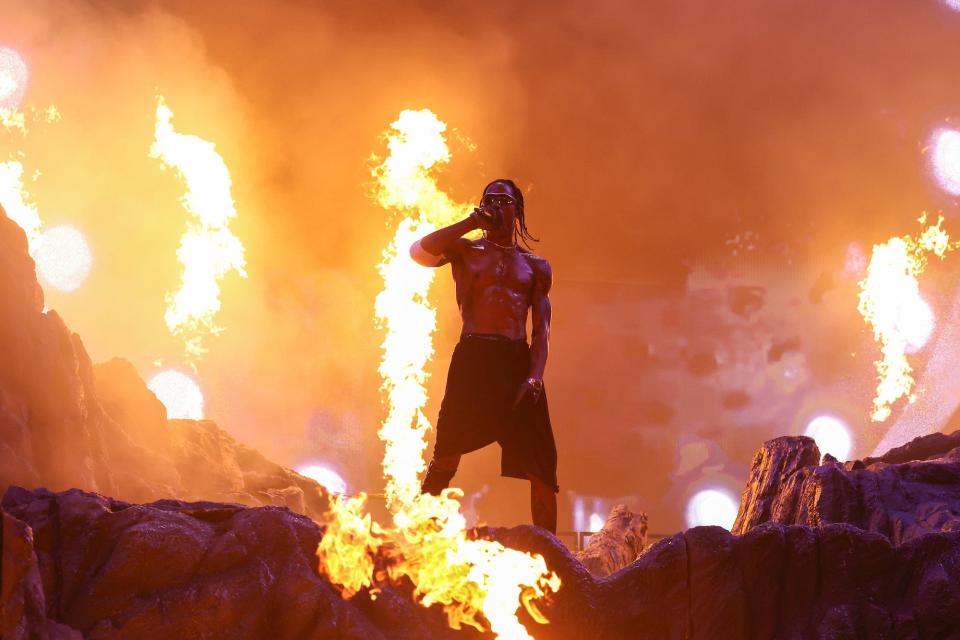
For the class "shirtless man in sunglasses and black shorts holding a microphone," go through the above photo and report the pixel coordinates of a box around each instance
[410,179,559,533]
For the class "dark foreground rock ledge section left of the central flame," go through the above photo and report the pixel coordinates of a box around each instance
[0,487,464,640]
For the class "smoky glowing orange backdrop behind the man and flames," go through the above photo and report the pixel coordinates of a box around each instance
[0,0,960,532]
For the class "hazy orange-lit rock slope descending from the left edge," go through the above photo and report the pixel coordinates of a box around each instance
[0,209,327,519]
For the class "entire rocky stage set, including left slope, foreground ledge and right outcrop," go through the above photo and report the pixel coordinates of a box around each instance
[0,206,960,640]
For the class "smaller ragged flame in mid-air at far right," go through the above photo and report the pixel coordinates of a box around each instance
[858,214,958,422]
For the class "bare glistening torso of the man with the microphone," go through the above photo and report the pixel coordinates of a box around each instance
[452,239,547,340]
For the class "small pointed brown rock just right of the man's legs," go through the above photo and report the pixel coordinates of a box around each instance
[576,504,647,576]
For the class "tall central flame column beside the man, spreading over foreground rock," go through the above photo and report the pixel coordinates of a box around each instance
[317,110,560,638]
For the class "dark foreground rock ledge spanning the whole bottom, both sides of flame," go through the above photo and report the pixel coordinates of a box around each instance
[7,488,960,640]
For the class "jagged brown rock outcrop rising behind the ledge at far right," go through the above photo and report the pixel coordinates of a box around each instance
[733,432,960,544]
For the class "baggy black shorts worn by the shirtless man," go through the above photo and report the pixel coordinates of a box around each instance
[434,333,560,491]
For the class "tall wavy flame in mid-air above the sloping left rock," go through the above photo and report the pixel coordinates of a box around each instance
[150,96,247,363]
